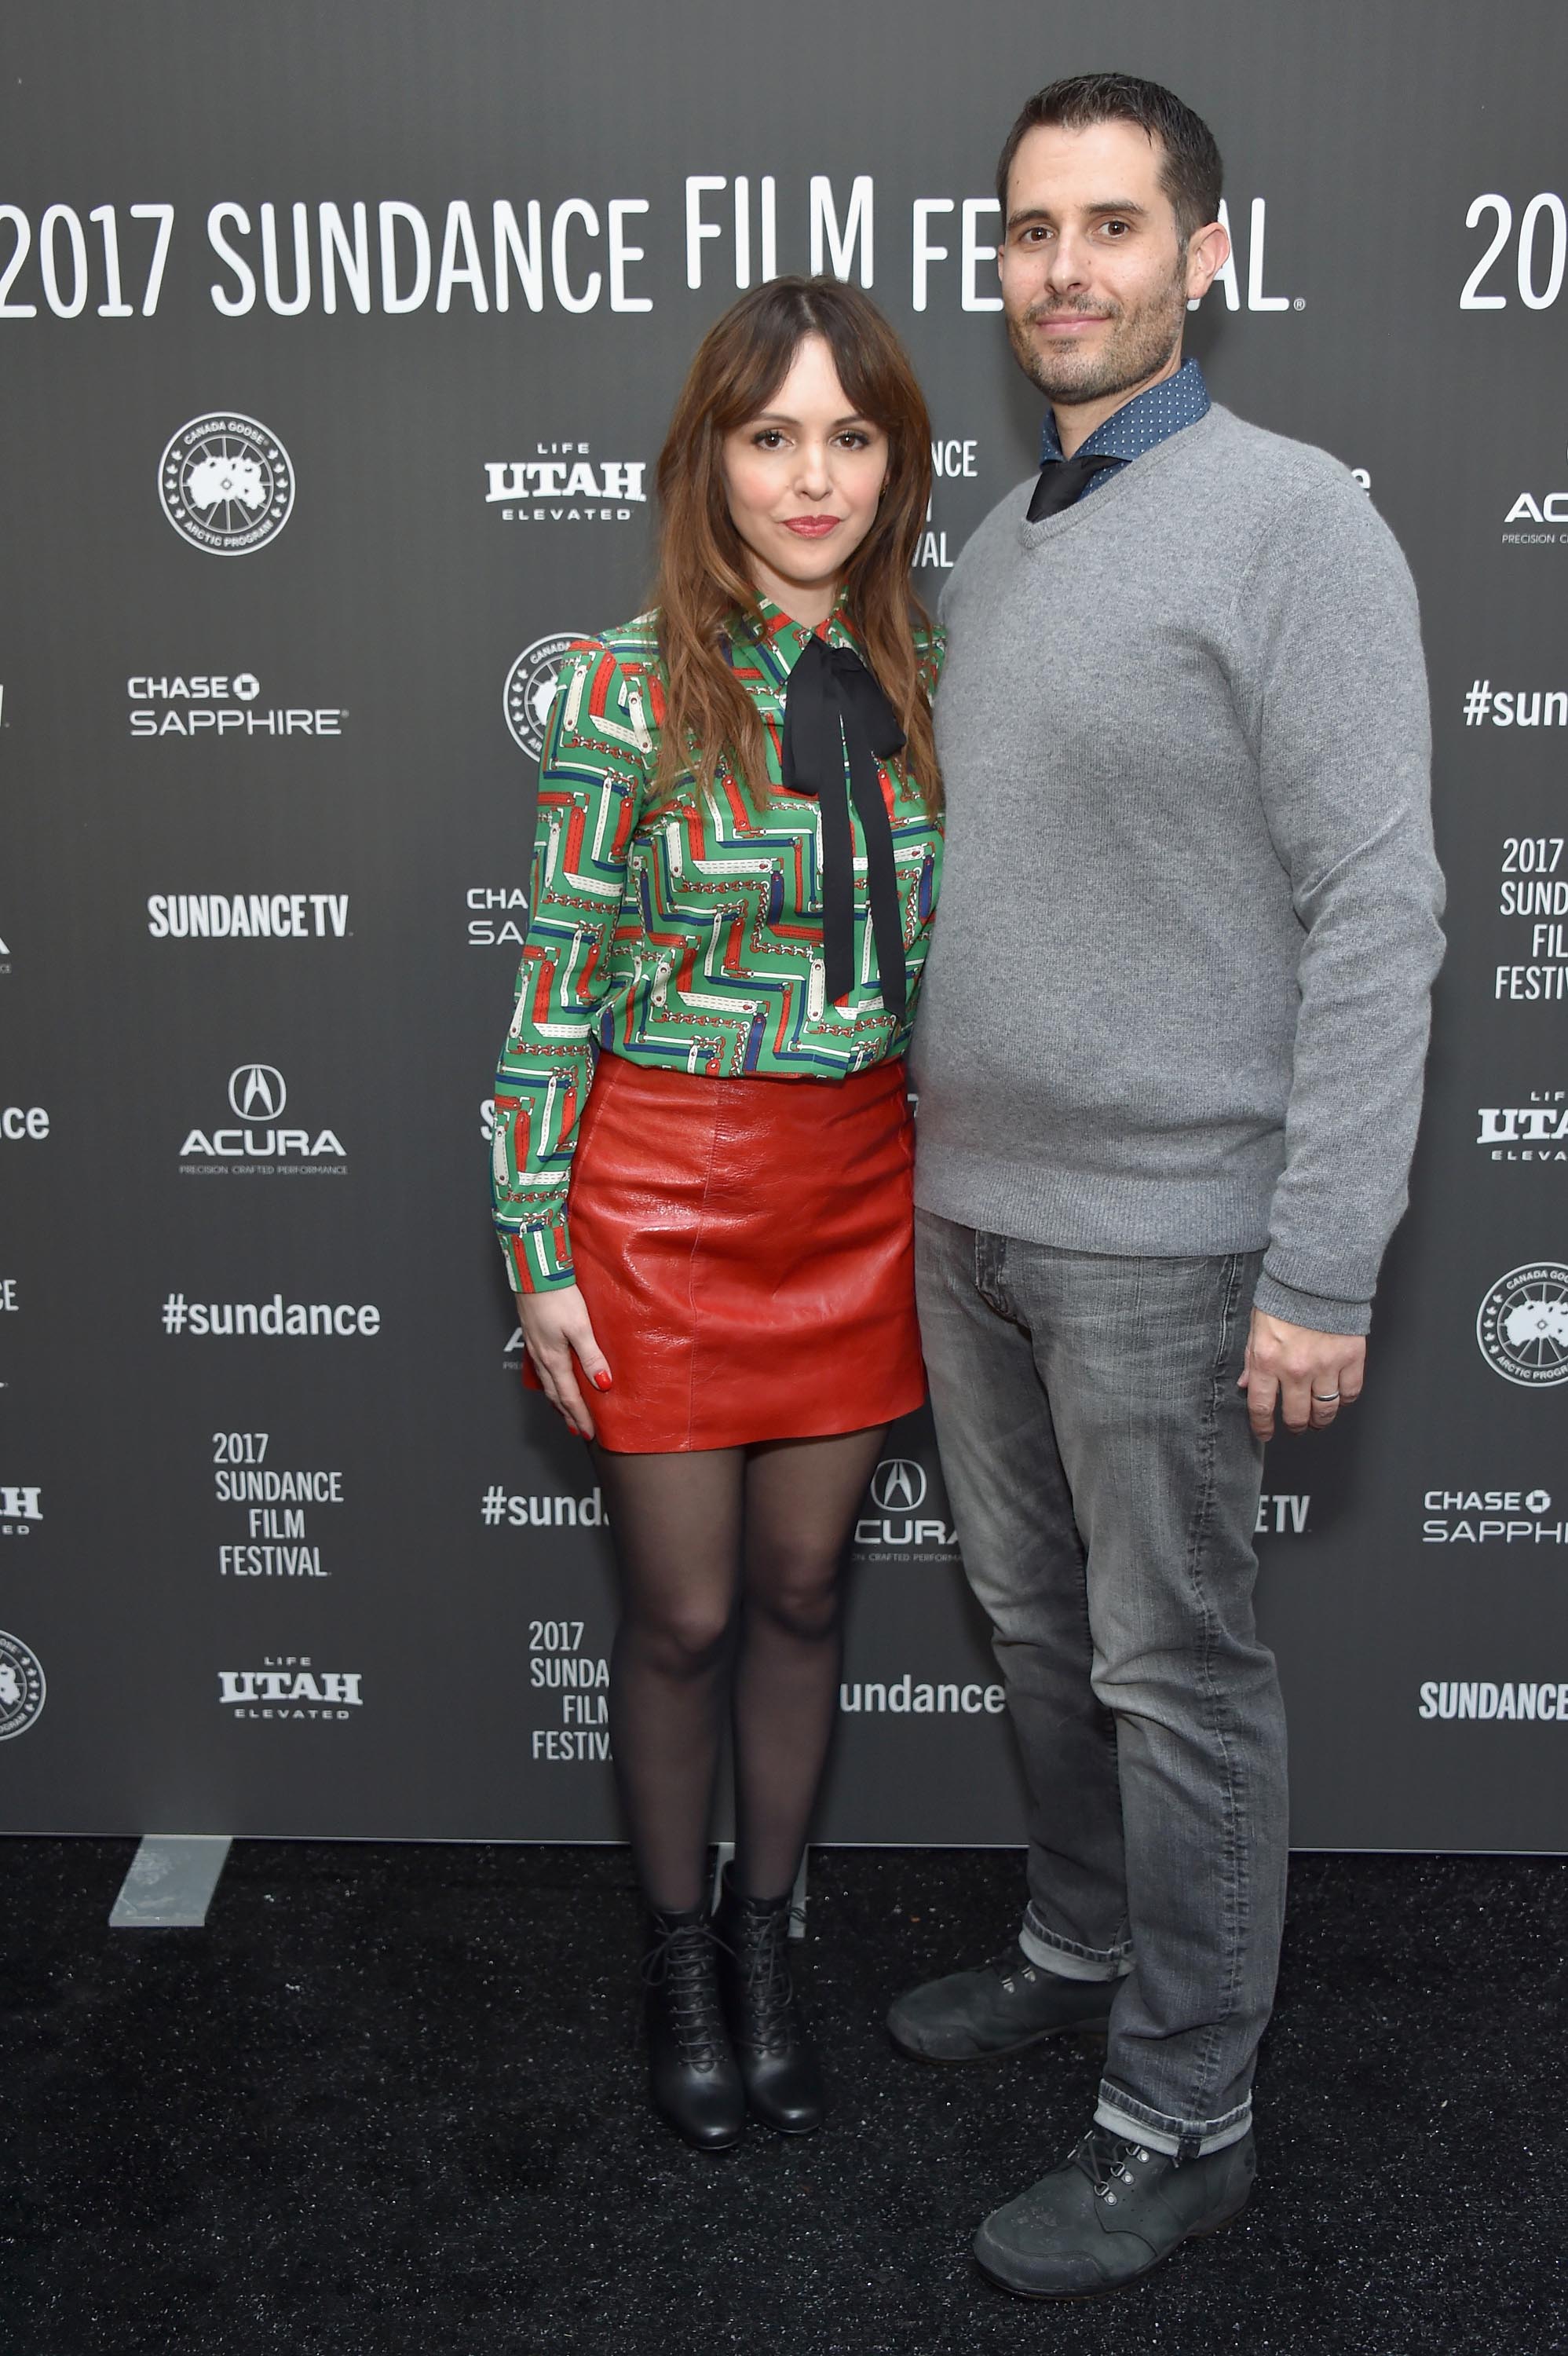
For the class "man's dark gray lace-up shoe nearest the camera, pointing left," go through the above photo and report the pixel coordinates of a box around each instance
[974,2127,1257,2299]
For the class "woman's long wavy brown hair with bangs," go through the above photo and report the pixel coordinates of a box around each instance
[655,278,941,810]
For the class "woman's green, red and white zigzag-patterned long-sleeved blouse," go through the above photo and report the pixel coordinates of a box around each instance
[492,598,941,1293]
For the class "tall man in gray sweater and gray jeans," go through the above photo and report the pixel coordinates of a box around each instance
[890,75,1441,2297]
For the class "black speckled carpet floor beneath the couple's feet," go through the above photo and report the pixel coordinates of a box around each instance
[0,1840,1568,2356]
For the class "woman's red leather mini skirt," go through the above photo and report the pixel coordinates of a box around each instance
[528,1055,925,1454]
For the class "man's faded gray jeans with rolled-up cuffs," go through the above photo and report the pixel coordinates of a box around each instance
[916,1211,1288,2158]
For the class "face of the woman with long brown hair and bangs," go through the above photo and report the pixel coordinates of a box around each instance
[723,335,890,629]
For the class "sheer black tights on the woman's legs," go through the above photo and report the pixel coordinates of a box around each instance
[596,1428,883,1913]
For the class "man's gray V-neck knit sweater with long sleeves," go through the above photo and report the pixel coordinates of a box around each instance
[913,408,1443,1333]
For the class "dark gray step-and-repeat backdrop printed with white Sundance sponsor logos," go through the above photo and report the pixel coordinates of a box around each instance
[0,0,1568,1849]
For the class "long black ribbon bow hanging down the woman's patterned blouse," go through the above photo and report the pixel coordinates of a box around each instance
[782,636,906,1020]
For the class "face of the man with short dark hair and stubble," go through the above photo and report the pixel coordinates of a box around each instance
[998,123,1226,405]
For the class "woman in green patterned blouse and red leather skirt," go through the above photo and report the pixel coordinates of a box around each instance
[495,278,941,2151]
